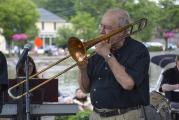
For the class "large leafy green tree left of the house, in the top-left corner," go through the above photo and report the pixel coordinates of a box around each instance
[0,0,38,45]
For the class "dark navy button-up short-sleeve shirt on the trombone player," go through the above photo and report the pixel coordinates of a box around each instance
[88,38,150,108]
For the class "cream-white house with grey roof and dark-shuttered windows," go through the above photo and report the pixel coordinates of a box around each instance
[36,8,70,48]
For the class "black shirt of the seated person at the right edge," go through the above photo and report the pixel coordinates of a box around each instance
[160,67,179,102]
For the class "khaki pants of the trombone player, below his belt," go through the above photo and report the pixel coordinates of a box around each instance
[90,109,145,120]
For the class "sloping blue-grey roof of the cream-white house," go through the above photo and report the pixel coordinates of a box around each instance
[38,8,66,23]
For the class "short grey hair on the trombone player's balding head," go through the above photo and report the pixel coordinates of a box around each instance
[105,8,131,26]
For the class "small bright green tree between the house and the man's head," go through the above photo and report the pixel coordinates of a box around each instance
[71,12,97,41]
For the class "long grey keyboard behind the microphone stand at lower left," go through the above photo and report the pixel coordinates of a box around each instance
[0,103,78,117]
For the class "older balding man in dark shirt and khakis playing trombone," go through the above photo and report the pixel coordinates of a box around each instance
[78,9,150,120]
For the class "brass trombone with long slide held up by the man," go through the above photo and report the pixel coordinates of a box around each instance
[8,18,147,99]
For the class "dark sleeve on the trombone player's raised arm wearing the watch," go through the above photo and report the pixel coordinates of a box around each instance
[125,50,150,87]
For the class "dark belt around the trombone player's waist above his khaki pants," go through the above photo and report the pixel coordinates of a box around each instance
[93,106,141,117]
